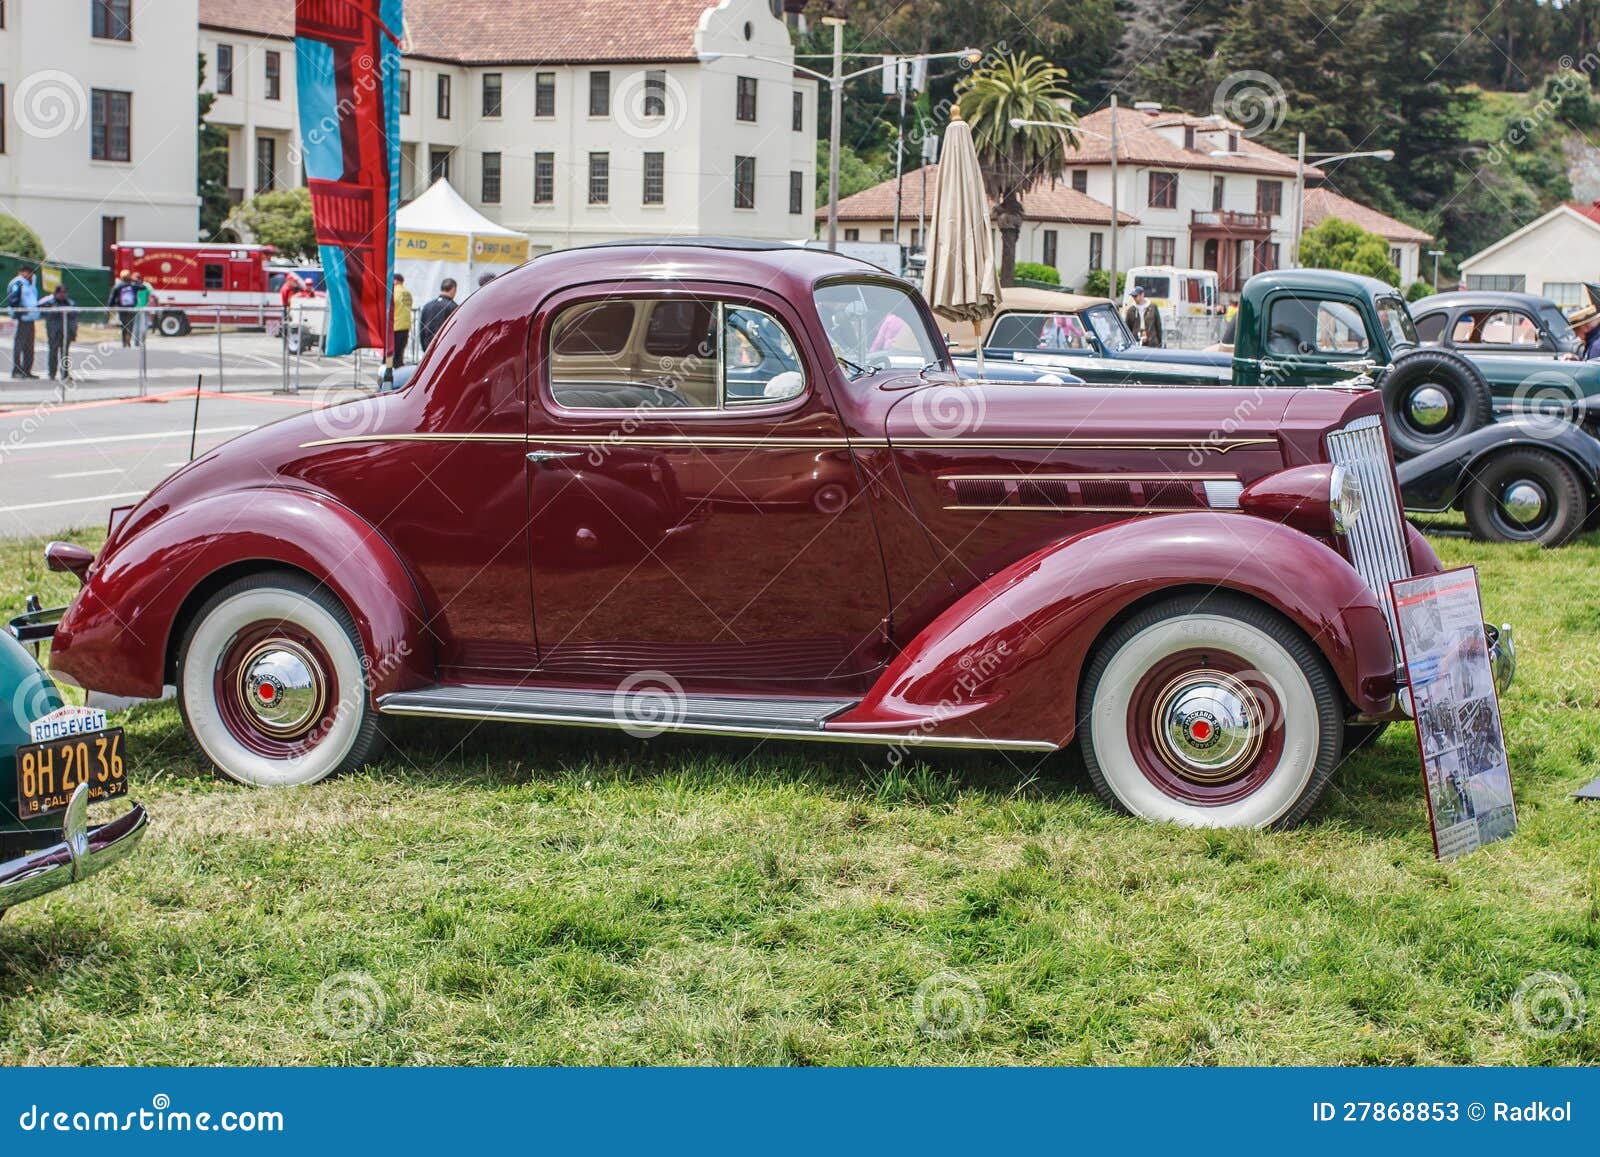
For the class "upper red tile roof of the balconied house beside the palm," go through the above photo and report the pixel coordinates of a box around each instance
[1066,106,1322,178]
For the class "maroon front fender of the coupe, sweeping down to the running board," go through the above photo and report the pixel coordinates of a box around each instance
[827,512,1395,746]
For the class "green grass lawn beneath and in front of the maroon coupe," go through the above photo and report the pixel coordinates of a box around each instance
[0,534,1600,1064]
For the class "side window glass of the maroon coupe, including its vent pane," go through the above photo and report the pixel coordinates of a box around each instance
[549,298,805,410]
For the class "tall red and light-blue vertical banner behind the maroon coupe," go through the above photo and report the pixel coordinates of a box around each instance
[294,0,403,354]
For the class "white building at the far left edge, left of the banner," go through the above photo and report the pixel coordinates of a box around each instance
[0,0,200,266]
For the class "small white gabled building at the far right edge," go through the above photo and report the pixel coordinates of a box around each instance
[1461,202,1600,307]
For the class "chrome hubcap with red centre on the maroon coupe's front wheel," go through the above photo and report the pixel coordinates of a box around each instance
[1155,671,1266,784]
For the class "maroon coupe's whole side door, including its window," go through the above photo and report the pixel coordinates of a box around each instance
[528,286,888,693]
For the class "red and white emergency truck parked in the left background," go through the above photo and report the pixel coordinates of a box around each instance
[110,242,283,338]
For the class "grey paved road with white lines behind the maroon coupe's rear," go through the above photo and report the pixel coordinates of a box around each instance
[0,389,354,538]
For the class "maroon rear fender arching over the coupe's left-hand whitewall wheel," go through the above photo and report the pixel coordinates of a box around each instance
[50,486,434,699]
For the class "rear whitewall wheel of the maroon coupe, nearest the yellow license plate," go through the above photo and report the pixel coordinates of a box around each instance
[178,571,381,787]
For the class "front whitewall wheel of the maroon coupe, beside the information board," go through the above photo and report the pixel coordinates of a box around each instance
[1078,594,1344,827]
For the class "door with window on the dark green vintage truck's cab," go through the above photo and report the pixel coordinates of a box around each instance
[1261,293,1382,386]
